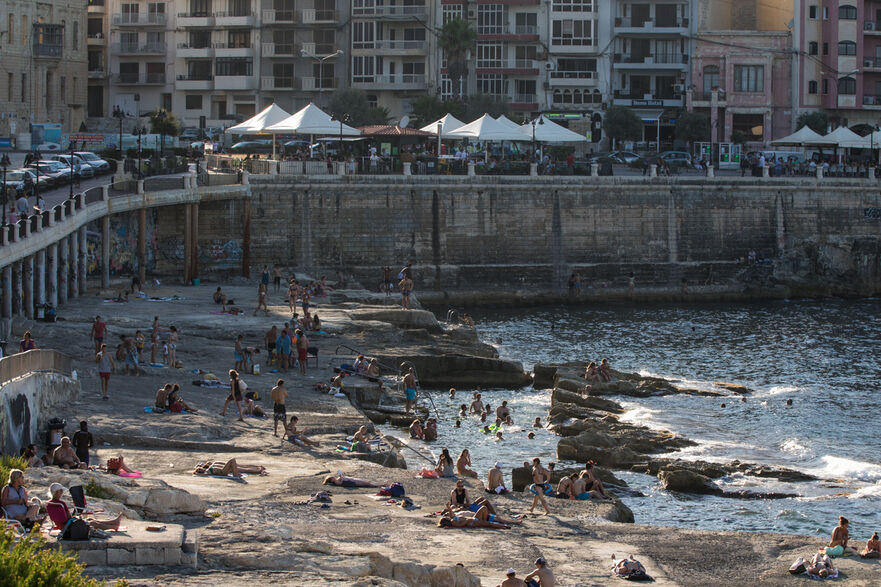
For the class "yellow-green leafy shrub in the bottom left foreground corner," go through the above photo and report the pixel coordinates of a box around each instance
[0,527,128,587]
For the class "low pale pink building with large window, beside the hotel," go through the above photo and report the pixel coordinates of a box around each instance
[686,31,793,146]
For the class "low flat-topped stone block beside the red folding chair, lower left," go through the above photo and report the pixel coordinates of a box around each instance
[58,520,199,567]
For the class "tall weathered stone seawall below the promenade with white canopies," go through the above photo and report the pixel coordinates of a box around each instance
[153,177,881,295]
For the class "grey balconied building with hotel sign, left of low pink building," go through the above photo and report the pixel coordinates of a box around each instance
[610,0,697,141]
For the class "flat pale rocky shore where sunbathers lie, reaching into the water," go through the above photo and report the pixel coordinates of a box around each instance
[13,284,877,587]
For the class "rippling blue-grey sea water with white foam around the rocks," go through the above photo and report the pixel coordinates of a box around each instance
[408,299,881,540]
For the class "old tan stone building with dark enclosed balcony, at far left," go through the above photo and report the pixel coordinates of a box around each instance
[0,0,87,149]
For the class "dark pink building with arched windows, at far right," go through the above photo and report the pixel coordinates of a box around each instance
[793,0,881,127]
